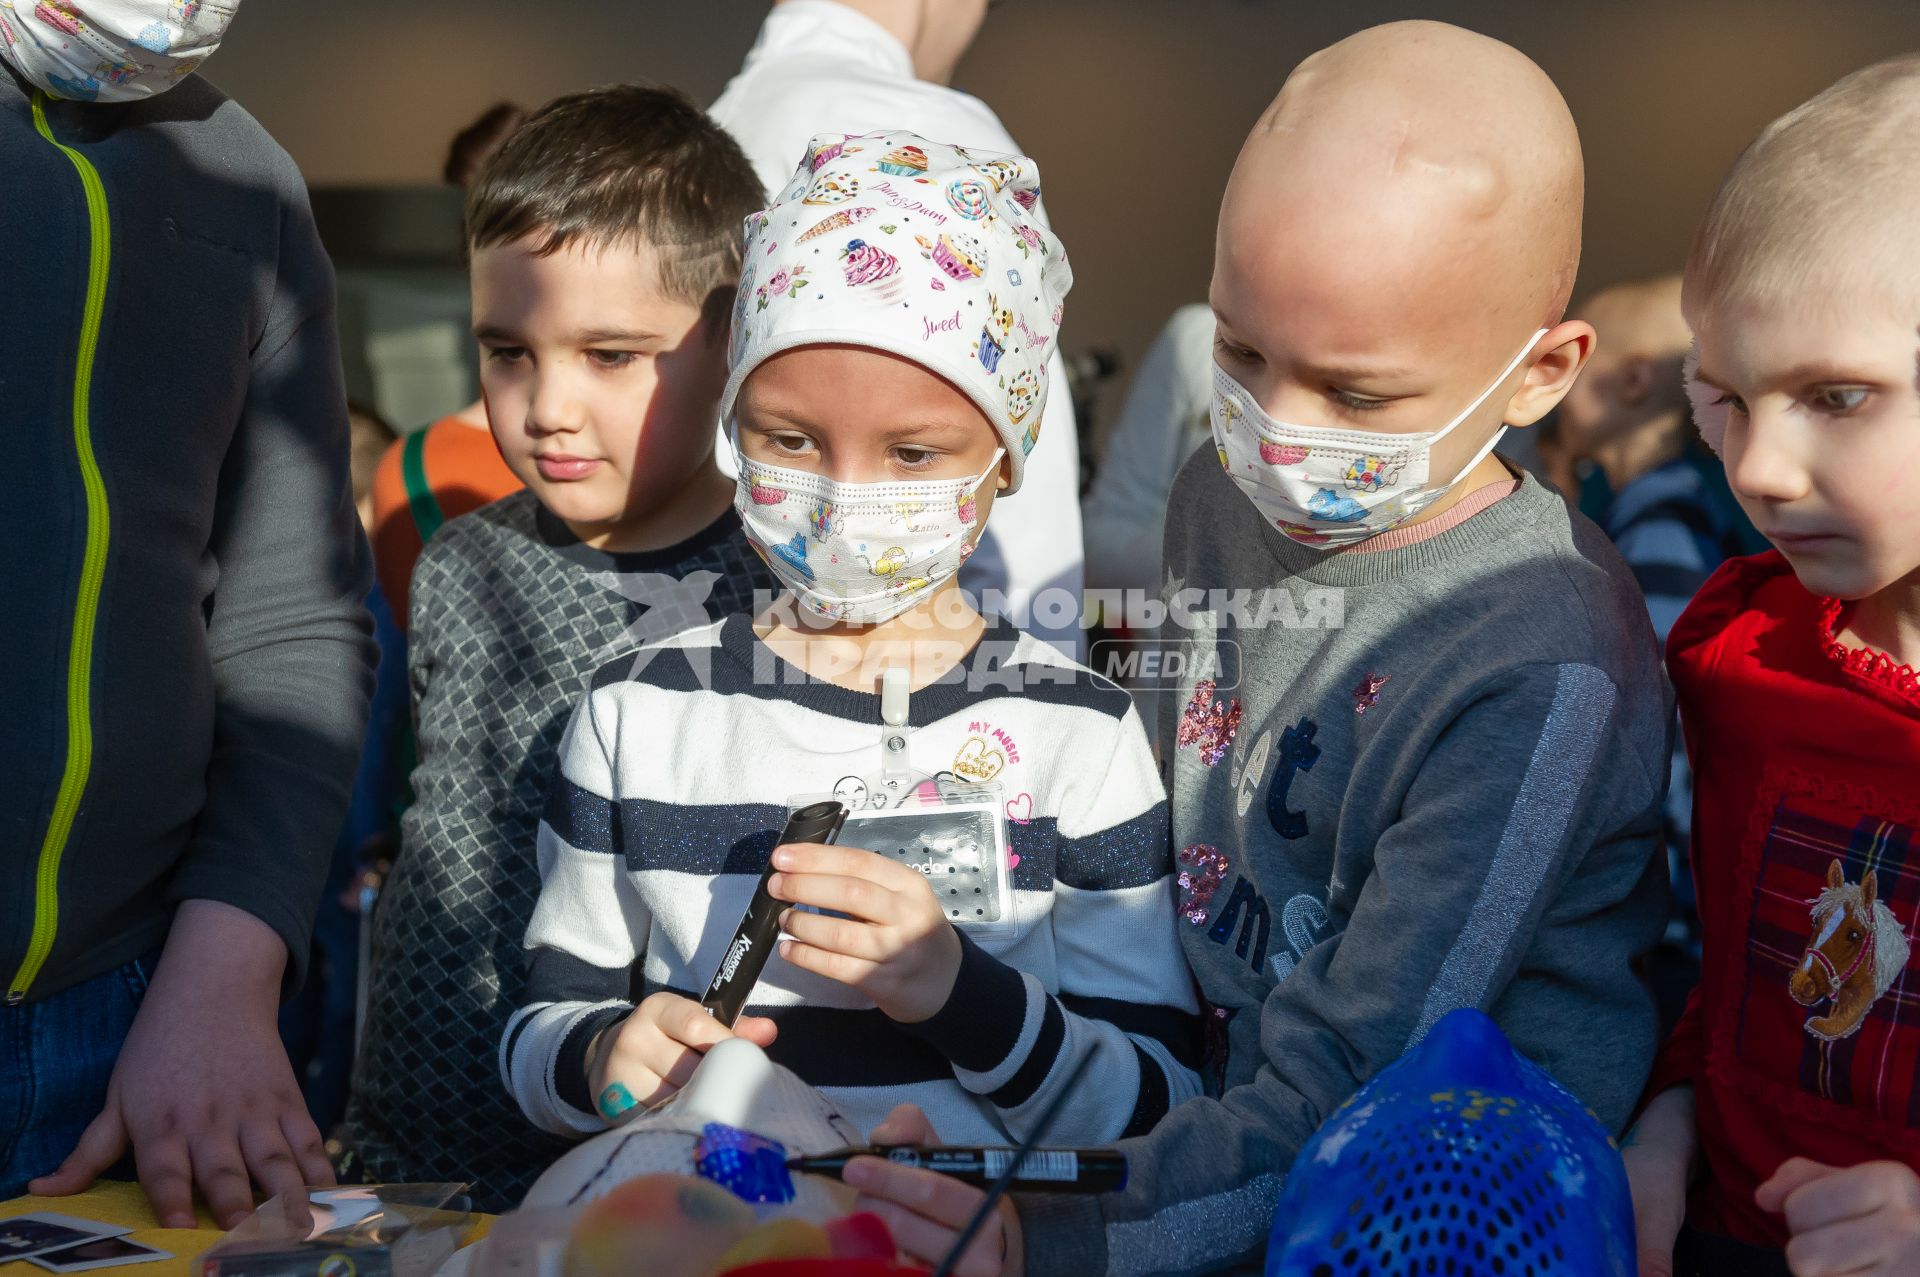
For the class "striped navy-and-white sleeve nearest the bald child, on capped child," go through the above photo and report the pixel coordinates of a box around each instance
[910,693,1200,1144]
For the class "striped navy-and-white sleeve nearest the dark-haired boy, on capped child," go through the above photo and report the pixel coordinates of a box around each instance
[499,689,649,1135]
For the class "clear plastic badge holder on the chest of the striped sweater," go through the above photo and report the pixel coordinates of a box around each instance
[793,776,1016,939]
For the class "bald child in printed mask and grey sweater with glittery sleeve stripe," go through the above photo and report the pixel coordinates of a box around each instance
[833,23,1668,1275]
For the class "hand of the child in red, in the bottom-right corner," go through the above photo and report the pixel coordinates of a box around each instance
[1753,1158,1920,1277]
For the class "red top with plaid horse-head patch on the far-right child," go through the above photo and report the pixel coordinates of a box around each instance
[1647,553,1920,1246]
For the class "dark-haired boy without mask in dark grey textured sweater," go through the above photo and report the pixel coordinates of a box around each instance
[349,86,772,1210]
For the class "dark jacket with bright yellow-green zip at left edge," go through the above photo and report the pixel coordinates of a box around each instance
[0,65,374,1002]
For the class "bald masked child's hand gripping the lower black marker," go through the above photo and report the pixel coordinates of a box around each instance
[841,1104,1025,1277]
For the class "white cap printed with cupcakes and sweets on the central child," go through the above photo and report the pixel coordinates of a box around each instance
[720,131,1073,492]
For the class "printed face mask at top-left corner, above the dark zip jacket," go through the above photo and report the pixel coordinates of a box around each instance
[0,0,240,102]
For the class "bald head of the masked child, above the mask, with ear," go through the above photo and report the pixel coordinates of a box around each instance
[1212,21,1586,472]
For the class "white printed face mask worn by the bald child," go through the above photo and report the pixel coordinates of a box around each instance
[1212,328,1548,549]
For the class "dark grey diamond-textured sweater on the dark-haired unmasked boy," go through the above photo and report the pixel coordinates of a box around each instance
[348,492,776,1212]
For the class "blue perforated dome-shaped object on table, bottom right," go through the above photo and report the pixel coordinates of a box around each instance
[1267,1010,1636,1277]
